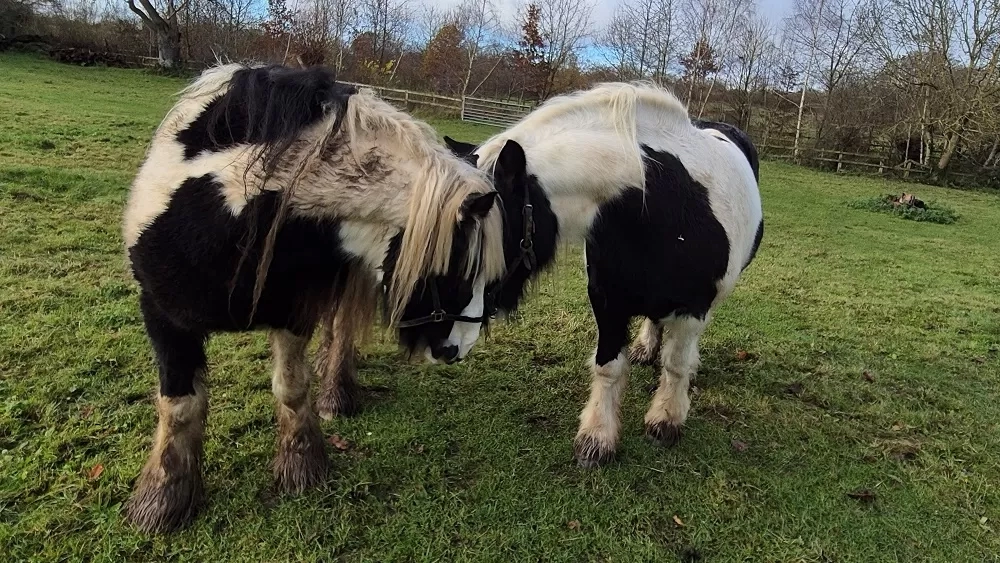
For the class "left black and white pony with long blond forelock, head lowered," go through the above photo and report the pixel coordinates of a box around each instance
[123,65,504,531]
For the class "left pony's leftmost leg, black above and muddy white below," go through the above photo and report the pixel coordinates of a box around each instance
[126,295,208,533]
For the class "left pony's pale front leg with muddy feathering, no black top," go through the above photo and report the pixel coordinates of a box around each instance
[271,330,326,493]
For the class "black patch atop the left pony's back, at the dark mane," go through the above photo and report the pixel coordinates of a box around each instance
[177,66,357,163]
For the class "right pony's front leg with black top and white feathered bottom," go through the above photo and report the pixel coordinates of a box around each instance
[573,289,629,468]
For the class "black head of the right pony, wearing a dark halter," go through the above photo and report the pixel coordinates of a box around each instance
[444,137,559,338]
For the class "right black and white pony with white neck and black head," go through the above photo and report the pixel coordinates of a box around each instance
[445,84,764,467]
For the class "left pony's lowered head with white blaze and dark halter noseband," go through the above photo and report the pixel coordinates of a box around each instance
[383,191,502,364]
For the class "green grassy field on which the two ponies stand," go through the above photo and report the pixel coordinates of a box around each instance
[0,55,1000,561]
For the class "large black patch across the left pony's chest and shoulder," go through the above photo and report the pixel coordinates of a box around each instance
[129,174,352,334]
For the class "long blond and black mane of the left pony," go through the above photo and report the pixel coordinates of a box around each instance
[174,64,504,322]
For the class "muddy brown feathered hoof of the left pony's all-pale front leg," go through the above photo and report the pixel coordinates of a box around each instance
[272,426,327,495]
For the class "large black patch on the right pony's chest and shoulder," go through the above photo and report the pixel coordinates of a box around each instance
[586,147,730,365]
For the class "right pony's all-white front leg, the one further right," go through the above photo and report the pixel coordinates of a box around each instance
[645,317,708,446]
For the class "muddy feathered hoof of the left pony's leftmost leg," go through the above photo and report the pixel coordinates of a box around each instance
[125,454,205,534]
